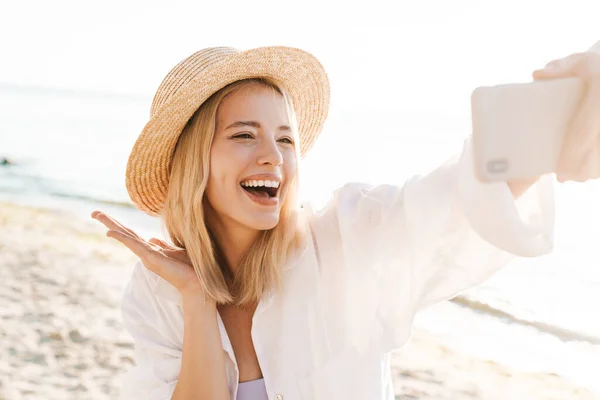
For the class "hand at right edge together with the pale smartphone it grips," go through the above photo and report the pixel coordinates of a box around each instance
[472,46,600,182]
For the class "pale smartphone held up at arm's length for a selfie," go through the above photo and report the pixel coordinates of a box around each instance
[471,78,585,182]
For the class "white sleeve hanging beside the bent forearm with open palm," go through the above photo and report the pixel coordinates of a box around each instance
[121,261,182,400]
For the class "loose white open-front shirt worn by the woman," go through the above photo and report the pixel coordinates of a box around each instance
[122,140,554,400]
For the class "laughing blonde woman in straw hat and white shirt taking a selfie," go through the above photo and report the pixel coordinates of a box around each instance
[92,47,600,400]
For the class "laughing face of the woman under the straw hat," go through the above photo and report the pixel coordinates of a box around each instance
[206,84,296,231]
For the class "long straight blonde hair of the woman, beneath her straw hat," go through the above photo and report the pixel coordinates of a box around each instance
[161,78,305,305]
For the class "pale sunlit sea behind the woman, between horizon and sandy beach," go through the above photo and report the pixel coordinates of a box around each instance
[0,83,600,393]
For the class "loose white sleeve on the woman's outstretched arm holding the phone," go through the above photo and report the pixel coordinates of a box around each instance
[315,140,554,351]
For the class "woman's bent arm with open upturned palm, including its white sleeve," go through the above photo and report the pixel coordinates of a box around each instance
[92,211,230,400]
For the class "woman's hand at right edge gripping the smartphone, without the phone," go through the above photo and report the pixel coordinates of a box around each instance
[533,50,600,182]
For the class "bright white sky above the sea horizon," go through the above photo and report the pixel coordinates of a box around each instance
[0,0,600,98]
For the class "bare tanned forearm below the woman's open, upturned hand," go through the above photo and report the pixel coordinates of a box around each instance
[172,297,230,400]
